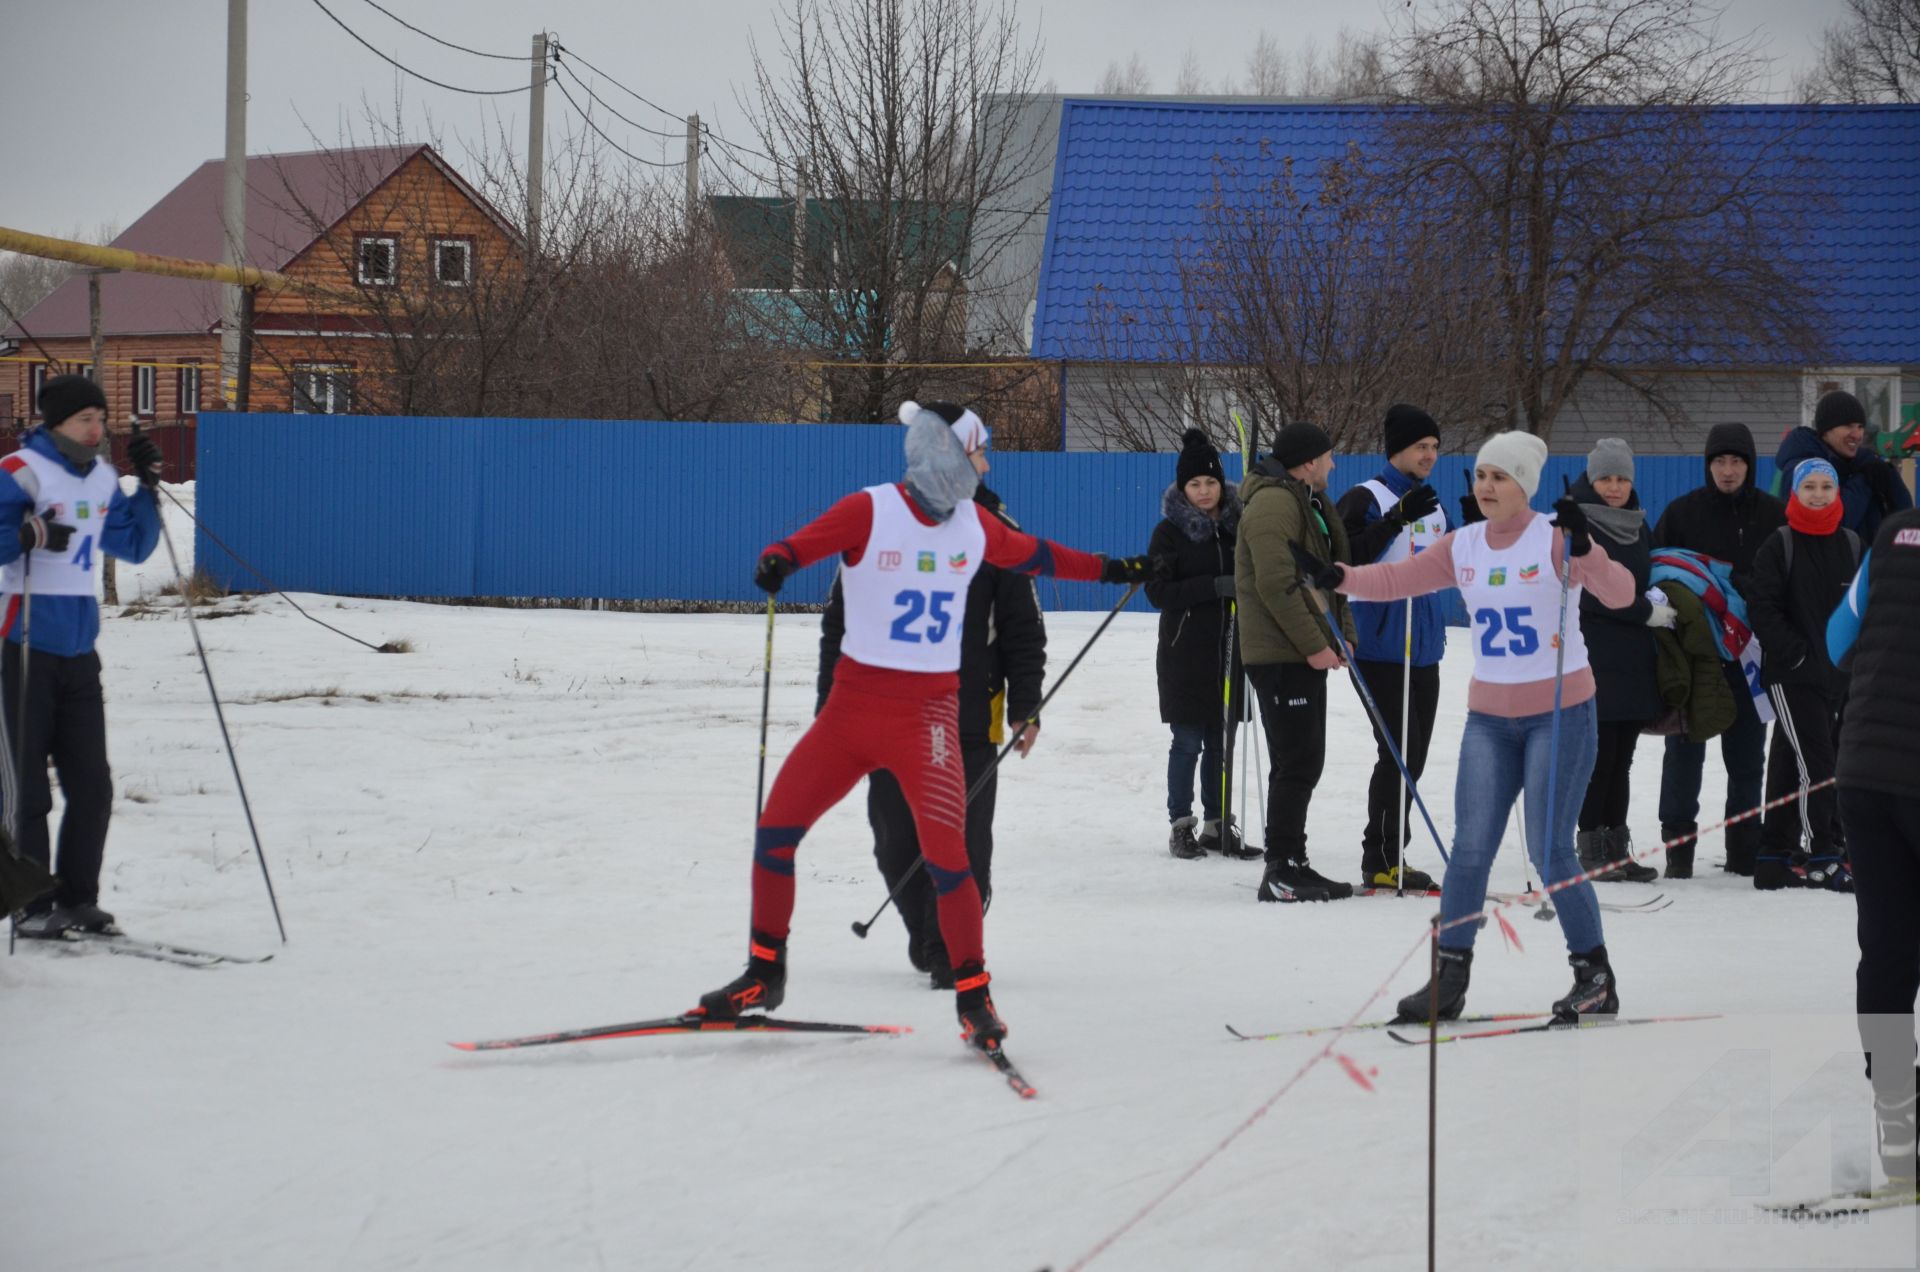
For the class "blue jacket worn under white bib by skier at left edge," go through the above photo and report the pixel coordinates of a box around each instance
[0,428,159,657]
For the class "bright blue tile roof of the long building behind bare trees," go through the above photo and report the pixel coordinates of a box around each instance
[1033,100,1920,365]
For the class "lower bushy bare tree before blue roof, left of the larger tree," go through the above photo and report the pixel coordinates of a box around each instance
[1089,146,1492,450]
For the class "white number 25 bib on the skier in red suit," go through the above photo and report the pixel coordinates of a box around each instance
[841,484,987,671]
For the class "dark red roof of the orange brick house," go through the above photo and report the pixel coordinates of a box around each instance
[0,146,516,340]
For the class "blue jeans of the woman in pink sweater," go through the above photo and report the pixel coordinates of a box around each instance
[1440,697,1607,953]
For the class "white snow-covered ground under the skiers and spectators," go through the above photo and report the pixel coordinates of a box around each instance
[0,484,1916,1272]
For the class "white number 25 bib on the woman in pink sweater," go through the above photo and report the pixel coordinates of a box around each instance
[1453,517,1586,684]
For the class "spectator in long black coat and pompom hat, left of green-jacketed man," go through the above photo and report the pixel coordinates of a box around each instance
[1146,428,1260,857]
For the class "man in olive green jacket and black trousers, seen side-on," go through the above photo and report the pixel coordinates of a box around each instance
[1233,423,1356,901]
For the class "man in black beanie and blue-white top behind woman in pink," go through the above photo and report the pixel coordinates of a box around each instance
[1338,404,1448,892]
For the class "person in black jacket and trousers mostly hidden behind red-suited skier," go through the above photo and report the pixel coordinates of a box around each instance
[814,402,1046,990]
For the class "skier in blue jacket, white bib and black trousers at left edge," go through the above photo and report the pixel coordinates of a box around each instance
[0,375,161,938]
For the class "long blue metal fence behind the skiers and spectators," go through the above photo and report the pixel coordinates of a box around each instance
[196,413,1772,609]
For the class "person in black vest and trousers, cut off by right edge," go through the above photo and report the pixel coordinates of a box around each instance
[1826,509,1920,1187]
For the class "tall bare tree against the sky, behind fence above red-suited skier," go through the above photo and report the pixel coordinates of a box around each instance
[747,0,1041,423]
